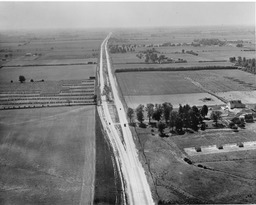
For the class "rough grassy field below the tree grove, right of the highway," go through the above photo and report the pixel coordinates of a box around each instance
[136,128,256,204]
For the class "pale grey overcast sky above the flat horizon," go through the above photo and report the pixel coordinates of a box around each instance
[0,2,255,29]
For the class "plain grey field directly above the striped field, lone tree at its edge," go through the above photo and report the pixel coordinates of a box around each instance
[0,65,96,82]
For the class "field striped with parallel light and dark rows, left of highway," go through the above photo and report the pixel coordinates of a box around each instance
[0,79,95,109]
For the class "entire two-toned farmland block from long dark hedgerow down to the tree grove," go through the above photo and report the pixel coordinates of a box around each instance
[116,69,256,108]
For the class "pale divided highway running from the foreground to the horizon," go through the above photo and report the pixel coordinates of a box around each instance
[98,33,154,205]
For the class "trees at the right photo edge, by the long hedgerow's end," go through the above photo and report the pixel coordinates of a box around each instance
[229,56,256,74]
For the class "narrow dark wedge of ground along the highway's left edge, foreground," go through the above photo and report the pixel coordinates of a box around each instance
[94,109,122,204]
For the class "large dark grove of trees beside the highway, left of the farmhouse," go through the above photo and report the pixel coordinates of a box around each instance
[127,102,221,134]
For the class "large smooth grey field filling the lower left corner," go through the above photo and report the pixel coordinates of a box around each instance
[0,106,95,204]
